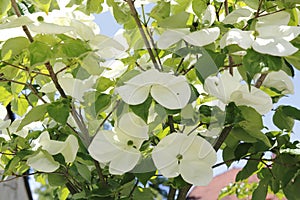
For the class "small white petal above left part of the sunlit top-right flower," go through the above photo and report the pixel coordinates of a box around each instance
[222,8,252,24]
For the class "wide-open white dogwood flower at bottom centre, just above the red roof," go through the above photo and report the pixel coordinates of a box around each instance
[152,133,217,186]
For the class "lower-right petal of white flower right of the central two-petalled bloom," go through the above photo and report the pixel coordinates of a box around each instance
[230,85,273,115]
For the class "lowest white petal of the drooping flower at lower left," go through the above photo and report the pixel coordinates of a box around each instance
[27,151,59,172]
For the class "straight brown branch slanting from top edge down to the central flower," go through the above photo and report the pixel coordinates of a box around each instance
[126,0,162,71]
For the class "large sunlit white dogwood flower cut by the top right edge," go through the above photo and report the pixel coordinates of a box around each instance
[220,12,300,56]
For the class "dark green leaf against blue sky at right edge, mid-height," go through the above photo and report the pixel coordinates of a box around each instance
[273,106,295,131]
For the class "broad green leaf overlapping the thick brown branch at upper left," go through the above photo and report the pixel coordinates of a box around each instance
[29,41,52,66]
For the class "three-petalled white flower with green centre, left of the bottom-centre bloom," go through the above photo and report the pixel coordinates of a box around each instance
[88,113,149,175]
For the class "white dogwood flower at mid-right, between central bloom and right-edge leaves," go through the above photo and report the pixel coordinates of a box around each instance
[204,71,273,114]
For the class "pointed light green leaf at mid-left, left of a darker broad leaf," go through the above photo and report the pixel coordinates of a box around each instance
[17,104,48,131]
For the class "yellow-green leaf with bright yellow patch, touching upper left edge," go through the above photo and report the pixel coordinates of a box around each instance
[1,37,30,60]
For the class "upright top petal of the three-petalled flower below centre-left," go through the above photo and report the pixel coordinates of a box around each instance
[118,112,149,140]
